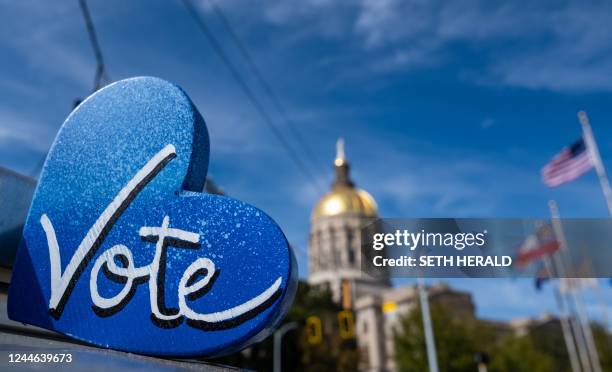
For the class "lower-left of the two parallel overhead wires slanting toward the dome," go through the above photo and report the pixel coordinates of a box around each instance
[183,0,326,192]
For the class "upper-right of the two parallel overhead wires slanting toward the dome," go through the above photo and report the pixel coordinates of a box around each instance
[209,0,322,177]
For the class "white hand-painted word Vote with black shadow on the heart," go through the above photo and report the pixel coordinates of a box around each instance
[40,145,282,329]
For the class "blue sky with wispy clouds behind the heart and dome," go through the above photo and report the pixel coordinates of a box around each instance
[0,0,612,319]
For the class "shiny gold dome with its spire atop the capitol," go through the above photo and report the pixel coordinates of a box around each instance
[311,138,378,220]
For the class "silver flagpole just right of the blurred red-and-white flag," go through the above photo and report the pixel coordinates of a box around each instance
[548,200,601,372]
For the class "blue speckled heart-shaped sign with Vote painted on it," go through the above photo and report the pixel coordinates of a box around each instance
[8,77,297,357]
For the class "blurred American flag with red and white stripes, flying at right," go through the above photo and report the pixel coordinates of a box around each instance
[542,138,593,187]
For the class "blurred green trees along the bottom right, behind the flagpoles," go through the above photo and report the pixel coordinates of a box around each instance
[394,304,612,372]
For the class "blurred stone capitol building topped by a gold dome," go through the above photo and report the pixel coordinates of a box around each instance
[308,139,474,371]
